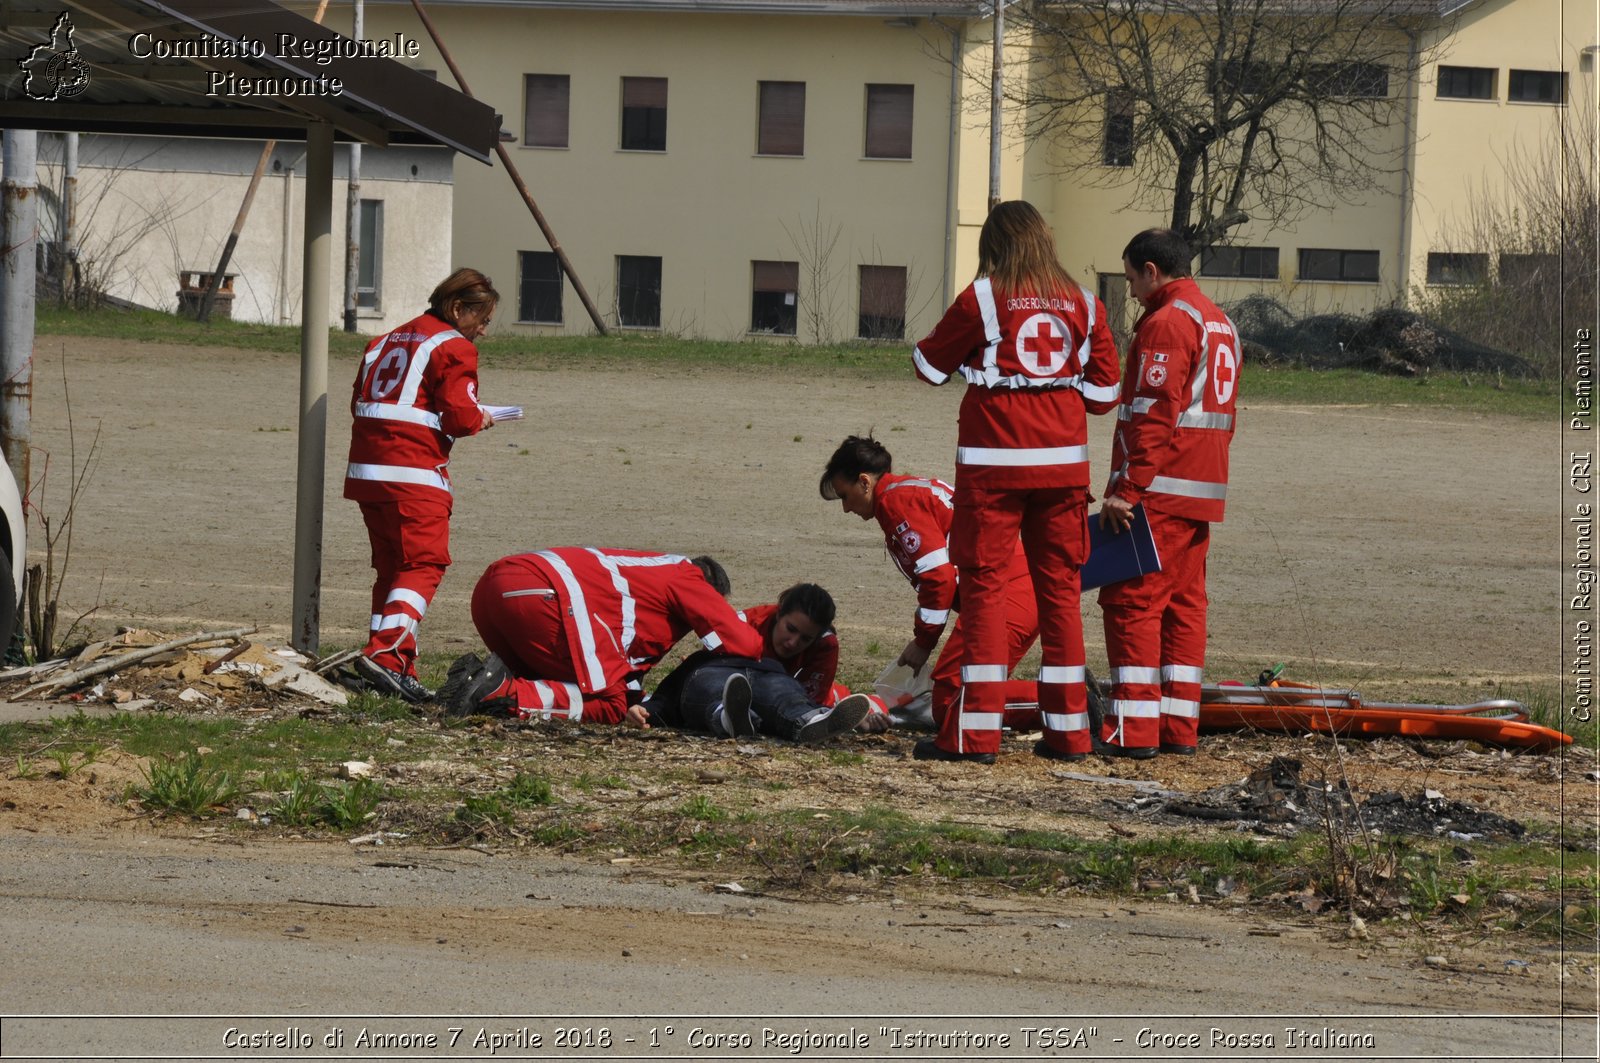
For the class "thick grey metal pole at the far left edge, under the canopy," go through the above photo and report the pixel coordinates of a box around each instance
[0,130,38,499]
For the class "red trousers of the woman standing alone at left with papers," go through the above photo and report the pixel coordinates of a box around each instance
[360,499,450,676]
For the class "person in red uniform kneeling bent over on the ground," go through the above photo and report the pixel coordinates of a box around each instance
[440,546,762,727]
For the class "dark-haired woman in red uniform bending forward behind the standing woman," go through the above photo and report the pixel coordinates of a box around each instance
[818,435,1038,760]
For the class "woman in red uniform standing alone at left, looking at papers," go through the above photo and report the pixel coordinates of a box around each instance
[344,269,499,701]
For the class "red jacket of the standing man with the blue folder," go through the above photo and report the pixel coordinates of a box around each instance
[1106,277,1240,520]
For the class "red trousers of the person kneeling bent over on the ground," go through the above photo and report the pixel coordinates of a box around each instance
[472,559,627,724]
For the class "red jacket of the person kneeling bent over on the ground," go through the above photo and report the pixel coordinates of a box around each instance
[507,546,762,695]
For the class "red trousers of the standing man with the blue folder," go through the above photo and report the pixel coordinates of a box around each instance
[1099,511,1211,749]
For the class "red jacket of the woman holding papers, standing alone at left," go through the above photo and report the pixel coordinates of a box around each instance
[344,312,483,503]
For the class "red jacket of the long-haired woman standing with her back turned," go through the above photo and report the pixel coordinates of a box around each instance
[912,277,1118,490]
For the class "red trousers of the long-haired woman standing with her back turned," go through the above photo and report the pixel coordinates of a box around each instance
[936,483,1090,752]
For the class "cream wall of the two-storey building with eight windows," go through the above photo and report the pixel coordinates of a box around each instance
[366,5,950,341]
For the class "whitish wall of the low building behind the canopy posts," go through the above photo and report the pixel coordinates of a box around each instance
[38,134,453,333]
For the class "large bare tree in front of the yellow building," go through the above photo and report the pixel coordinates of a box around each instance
[1005,0,1442,253]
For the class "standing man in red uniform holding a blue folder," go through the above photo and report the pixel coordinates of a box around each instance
[1099,229,1240,759]
